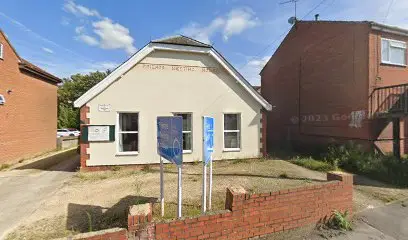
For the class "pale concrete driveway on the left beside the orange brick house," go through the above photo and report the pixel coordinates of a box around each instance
[0,155,79,239]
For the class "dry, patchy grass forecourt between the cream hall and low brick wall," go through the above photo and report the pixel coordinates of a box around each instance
[9,159,326,240]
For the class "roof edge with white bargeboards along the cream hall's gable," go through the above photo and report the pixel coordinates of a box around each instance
[74,36,272,111]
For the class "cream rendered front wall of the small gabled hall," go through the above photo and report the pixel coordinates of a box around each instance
[75,36,269,166]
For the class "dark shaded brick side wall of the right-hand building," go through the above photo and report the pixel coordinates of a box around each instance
[261,21,369,151]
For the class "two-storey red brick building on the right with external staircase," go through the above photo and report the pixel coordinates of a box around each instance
[261,21,408,154]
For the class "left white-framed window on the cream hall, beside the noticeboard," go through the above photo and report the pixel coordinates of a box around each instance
[116,112,139,155]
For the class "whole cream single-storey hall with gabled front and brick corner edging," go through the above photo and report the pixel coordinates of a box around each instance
[74,36,271,171]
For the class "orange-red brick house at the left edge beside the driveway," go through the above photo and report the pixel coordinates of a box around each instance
[0,30,61,164]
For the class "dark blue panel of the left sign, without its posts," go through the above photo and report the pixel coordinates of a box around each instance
[157,117,183,166]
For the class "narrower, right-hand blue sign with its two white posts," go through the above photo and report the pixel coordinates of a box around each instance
[201,117,214,213]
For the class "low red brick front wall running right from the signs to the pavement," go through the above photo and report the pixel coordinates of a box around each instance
[151,173,353,240]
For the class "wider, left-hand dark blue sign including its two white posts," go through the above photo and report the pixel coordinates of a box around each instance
[157,117,183,218]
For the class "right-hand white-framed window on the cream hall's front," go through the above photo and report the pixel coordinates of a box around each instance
[223,113,241,151]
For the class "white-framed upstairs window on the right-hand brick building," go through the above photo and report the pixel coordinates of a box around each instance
[381,38,407,66]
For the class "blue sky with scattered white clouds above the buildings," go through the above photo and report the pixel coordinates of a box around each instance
[0,0,408,84]
